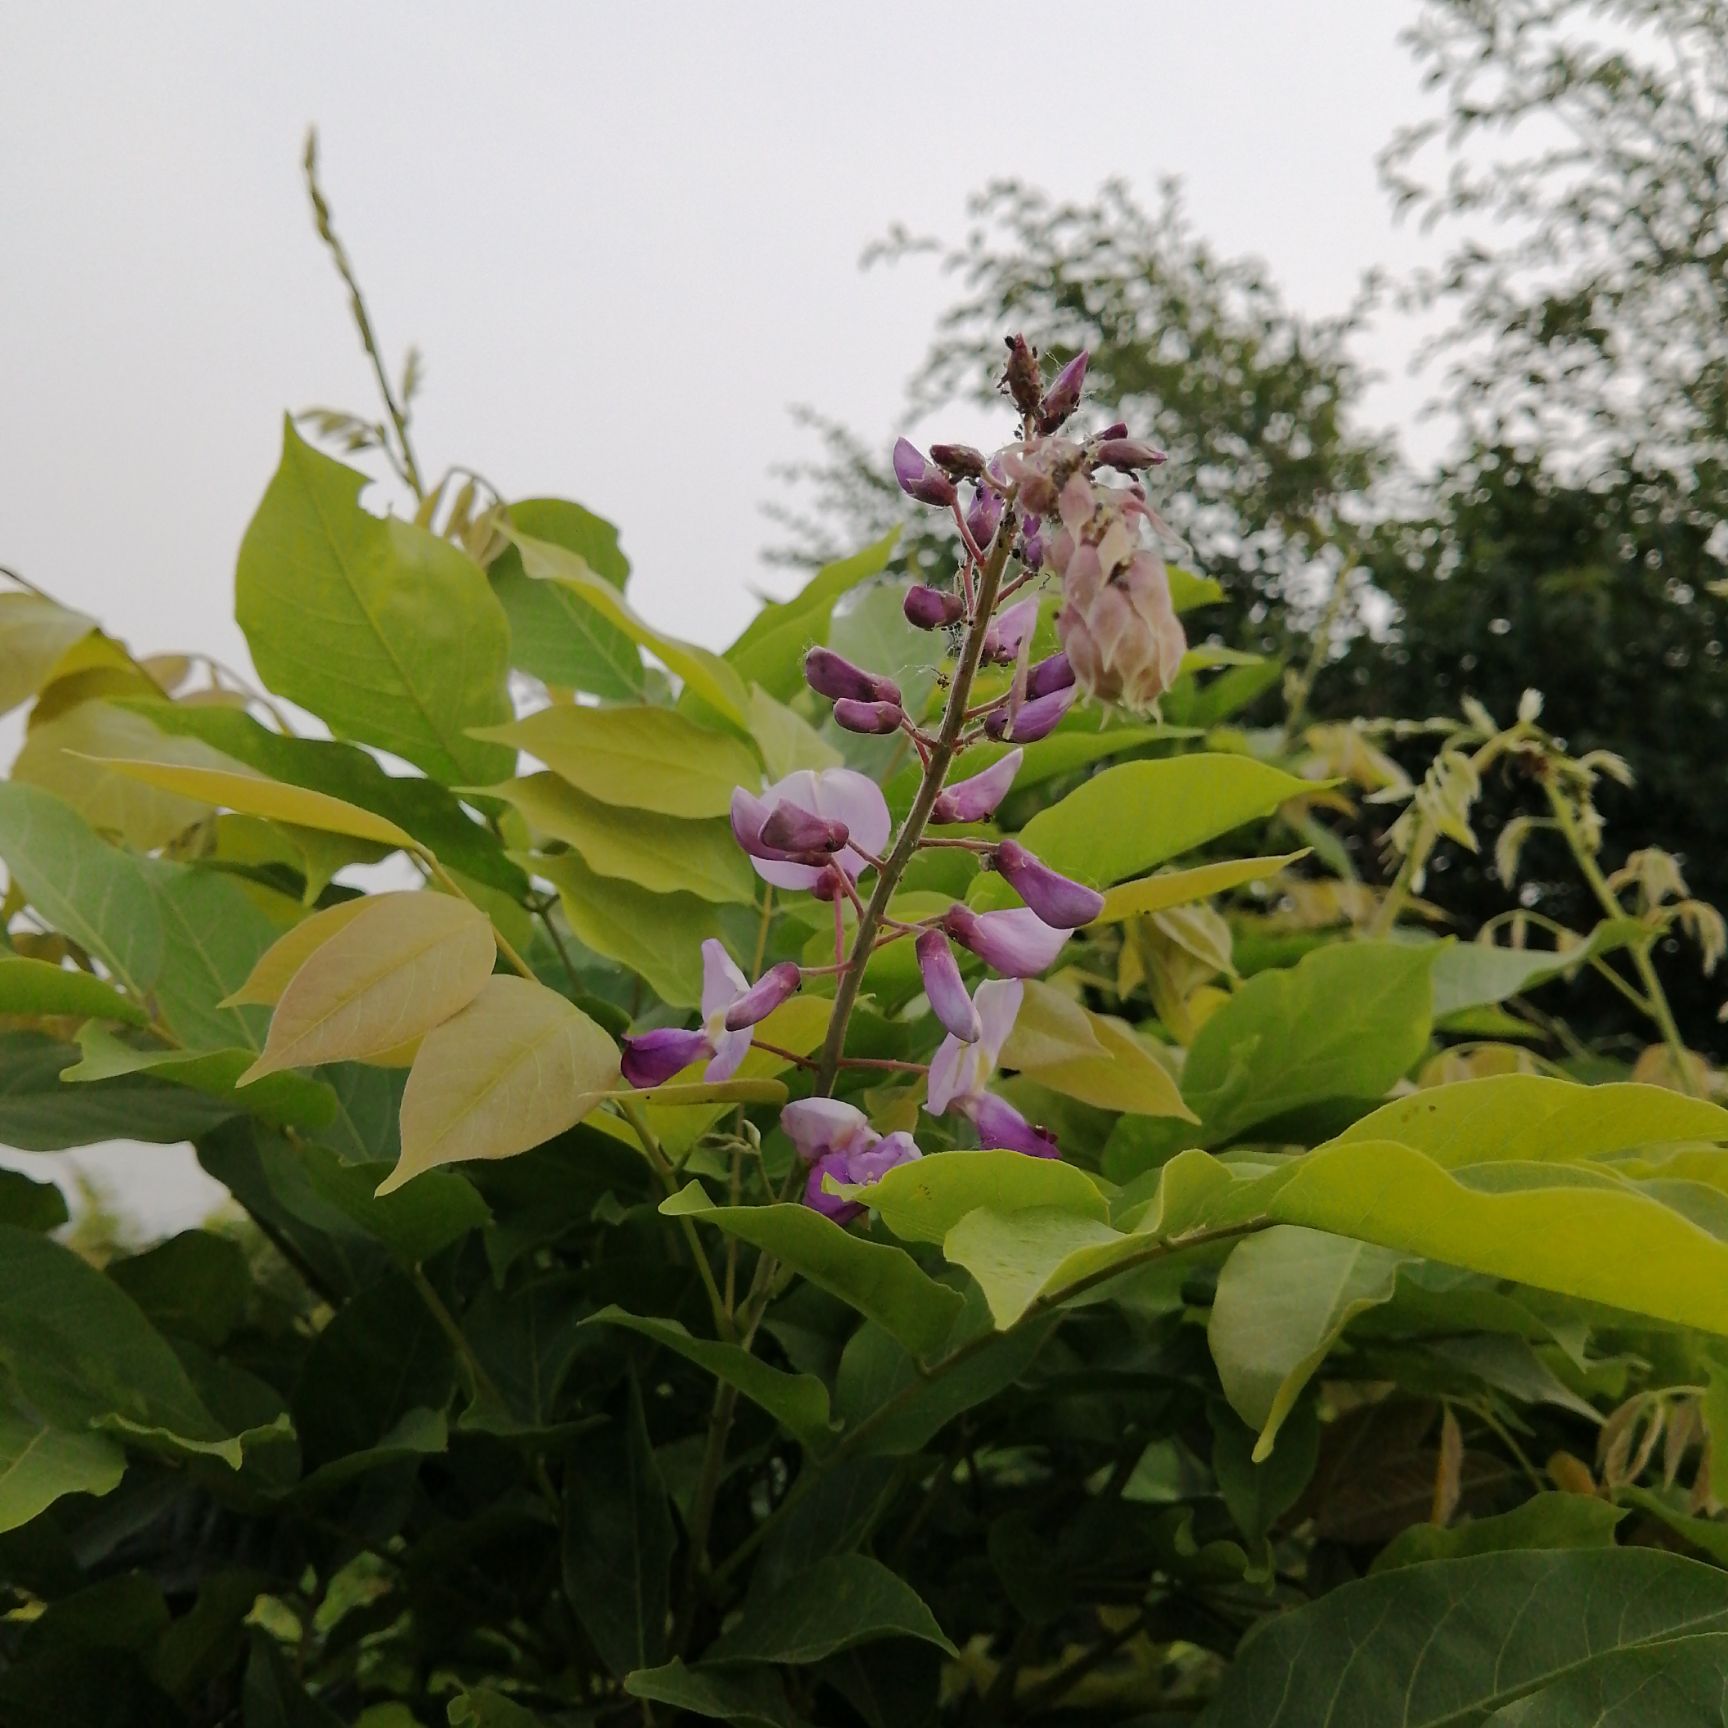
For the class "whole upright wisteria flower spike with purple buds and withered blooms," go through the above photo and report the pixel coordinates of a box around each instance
[624,335,1187,1223]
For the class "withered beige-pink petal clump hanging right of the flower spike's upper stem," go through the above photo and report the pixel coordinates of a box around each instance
[1056,551,1187,710]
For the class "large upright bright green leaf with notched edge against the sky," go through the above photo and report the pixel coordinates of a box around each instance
[235,422,510,785]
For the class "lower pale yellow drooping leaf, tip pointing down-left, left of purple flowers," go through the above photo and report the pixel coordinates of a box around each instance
[385,981,619,1194]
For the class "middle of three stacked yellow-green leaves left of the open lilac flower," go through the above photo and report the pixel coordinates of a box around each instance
[487,774,759,905]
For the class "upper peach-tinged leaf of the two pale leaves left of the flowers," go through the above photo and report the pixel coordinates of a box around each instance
[242,893,496,1083]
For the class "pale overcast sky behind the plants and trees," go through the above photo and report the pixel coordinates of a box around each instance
[0,0,1444,1230]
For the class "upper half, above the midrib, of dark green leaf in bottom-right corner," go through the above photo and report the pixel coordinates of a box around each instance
[1201,1548,1728,1728]
